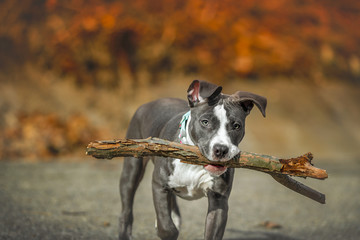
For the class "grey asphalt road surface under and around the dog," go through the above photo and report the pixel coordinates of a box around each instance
[0,158,360,240]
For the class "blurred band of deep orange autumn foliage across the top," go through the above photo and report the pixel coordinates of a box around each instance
[0,0,360,87]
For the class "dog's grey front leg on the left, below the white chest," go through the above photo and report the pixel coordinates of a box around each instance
[152,173,179,240]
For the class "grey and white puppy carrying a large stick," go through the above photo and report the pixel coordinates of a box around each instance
[119,80,267,240]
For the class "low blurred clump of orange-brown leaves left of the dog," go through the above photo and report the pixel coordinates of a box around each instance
[0,113,100,159]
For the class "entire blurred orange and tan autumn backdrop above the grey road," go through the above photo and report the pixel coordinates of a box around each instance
[0,0,360,161]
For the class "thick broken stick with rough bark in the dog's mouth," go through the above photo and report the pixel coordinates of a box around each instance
[86,138,328,204]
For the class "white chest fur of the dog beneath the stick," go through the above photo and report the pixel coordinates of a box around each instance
[169,159,213,200]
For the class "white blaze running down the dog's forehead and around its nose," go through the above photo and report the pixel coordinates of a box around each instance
[208,105,240,160]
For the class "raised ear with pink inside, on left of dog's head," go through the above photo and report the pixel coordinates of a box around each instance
[187,80,222,107]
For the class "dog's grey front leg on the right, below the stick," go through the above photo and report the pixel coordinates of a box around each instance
[205,191,228,240]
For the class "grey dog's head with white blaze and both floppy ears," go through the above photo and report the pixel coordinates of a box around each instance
[188,80,267,175]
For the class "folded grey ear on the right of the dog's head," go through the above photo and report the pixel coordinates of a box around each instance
[230,91,267,117]
